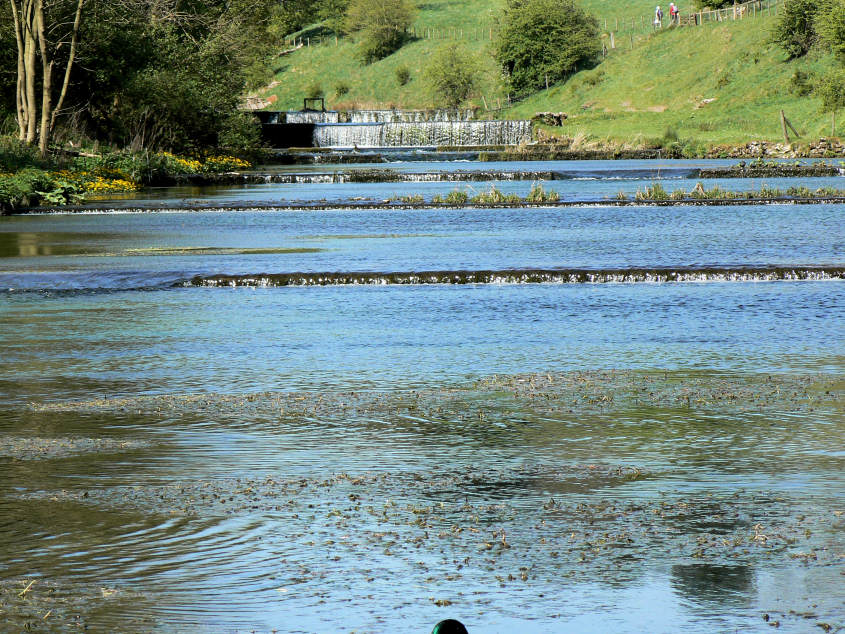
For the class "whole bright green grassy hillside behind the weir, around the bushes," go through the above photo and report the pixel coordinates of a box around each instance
[256,0,833,144]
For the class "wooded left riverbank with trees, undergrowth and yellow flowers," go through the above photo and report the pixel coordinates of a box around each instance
[0,0,280,210]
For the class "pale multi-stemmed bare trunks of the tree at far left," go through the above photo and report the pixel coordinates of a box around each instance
[10,0,85,156]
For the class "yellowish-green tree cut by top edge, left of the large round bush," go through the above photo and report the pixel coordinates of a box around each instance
[345,0,416,64]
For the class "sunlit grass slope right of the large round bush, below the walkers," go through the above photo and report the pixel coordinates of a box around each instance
[508,17,833,144]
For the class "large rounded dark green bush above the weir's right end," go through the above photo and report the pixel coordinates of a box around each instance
[494,0,601,93]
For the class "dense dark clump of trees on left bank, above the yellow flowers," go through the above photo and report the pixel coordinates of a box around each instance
[0,0,278,152]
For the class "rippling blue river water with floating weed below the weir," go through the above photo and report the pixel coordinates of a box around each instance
[0,161,845,632]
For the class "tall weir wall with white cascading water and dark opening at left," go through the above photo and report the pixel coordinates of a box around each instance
[256,110,531,148]
